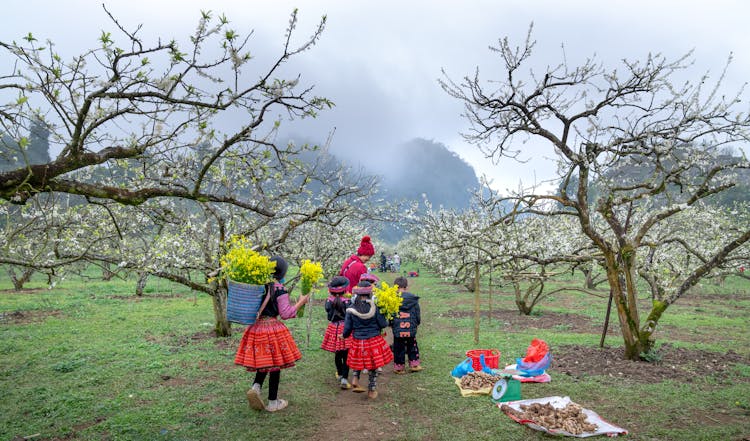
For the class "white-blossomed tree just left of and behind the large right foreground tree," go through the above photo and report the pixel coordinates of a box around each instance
[412,189,597,315]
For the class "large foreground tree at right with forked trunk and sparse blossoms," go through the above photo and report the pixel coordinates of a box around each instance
[441,29,750,360]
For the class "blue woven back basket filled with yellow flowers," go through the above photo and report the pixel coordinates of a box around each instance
[219,236,276,325]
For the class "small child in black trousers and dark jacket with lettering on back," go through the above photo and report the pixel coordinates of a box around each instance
[391,277,424,374]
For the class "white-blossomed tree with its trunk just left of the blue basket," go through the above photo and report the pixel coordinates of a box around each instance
[0,146,374,335]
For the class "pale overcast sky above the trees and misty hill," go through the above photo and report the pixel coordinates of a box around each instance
[0,0,750,190]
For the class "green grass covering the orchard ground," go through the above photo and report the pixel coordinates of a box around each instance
[0,267,750,441]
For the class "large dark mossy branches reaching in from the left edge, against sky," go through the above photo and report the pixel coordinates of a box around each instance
[0,11,332,205]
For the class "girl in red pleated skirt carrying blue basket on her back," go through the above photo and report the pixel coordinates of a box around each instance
[234,256,310,412]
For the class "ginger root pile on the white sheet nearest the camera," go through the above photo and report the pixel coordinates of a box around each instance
[500,403,599,435]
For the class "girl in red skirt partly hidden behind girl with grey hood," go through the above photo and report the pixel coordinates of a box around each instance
[320,276,352,389]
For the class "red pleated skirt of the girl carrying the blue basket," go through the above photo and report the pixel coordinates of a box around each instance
[234,317,302,372]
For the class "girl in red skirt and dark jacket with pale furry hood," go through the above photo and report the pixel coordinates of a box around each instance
[341,280,393,399]
